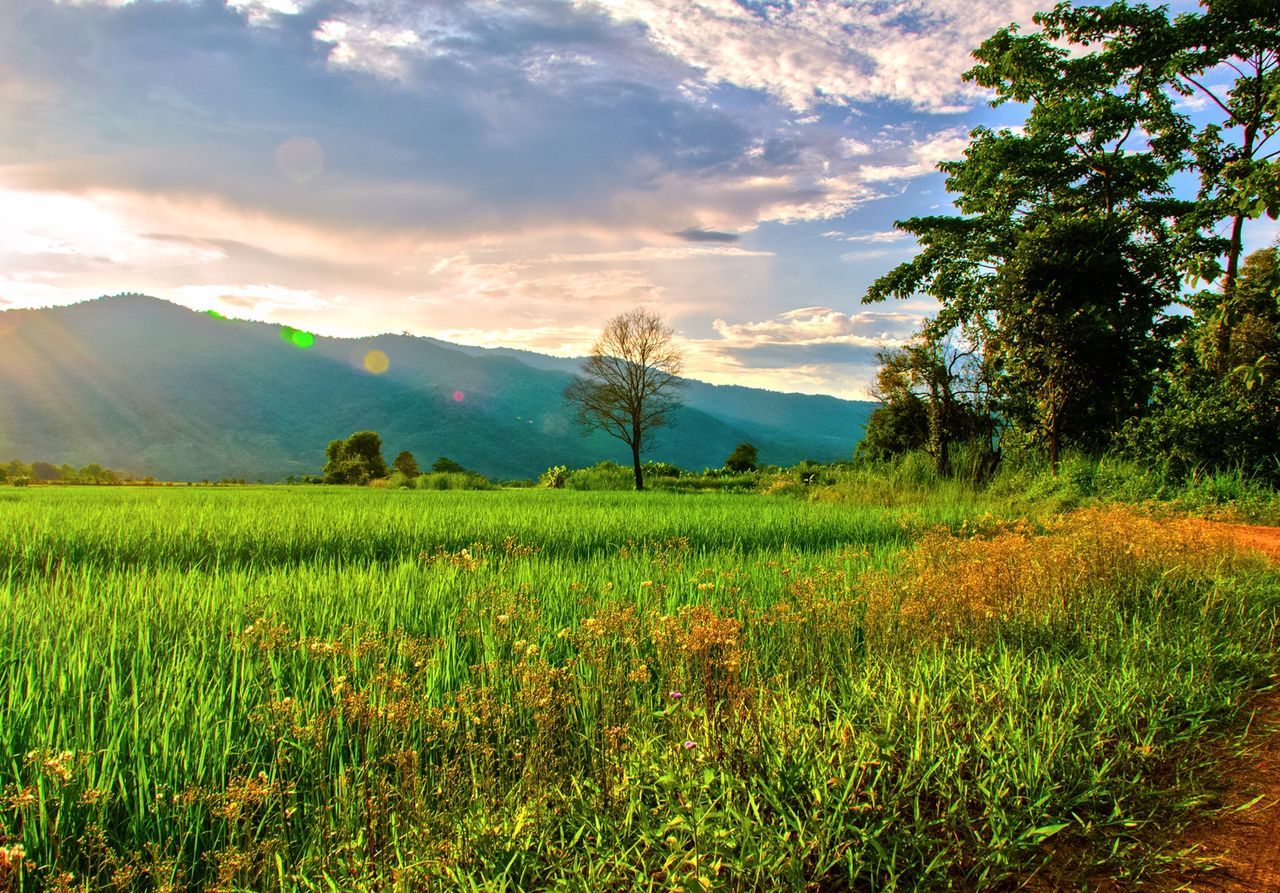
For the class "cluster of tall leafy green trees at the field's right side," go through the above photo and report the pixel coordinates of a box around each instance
[859,0,1280,480]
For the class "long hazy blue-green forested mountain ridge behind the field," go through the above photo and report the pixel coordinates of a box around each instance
[0,296,873,480]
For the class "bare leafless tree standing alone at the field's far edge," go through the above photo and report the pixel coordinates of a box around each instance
[564,307,684,490]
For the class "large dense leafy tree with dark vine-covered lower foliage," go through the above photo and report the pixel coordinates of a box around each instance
[864,4,1182,468]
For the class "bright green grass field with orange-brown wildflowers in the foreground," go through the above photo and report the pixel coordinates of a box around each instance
[0,487,1280,890]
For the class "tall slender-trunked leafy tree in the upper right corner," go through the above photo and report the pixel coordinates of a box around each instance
[1038,0,1280,375]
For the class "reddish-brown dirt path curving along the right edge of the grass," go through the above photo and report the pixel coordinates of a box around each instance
[1156,522,1280,893]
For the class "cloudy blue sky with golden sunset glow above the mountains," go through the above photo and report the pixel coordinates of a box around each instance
[0,0,1275,398]
